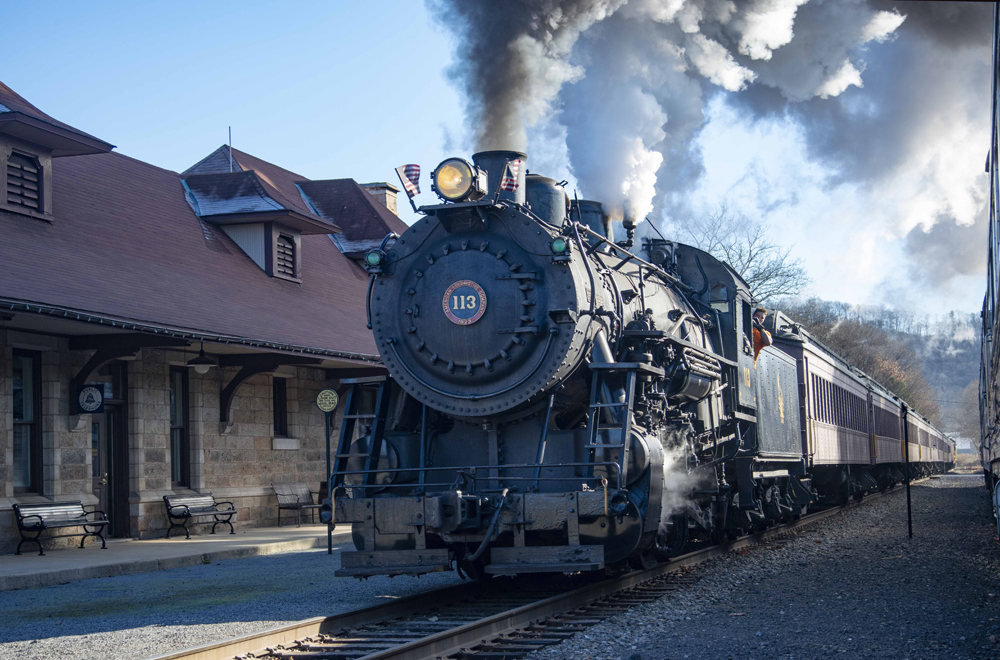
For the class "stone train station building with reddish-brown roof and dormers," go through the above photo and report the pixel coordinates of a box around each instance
[0,83,405,552]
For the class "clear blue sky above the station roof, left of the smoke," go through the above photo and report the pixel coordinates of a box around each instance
[0,0,462,197]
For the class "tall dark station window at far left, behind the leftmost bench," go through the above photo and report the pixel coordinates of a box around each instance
[13,349,42,493]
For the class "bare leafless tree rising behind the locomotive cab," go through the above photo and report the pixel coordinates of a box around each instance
[681,205,810,302]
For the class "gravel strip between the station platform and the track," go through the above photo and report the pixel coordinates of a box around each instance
[0,546,459,660]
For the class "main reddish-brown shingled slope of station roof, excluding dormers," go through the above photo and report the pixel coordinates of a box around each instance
[0,149,377,355]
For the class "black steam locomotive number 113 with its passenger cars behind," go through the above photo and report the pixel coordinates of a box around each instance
[325,151,954,577]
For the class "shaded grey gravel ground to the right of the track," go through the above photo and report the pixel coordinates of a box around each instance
[528,475,1000,660]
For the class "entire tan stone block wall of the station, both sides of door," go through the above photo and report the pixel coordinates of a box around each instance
[0,330,343,552]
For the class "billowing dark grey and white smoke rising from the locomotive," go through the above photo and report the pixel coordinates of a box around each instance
[431,0,992,306]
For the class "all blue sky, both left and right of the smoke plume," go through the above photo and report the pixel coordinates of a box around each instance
[0,0,988,312]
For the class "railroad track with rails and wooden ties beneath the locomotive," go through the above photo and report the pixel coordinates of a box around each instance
[150,488,903,660]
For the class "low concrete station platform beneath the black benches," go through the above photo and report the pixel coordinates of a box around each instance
[0,525,353,591]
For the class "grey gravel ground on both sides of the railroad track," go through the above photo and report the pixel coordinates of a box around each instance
[0,475,1000,660]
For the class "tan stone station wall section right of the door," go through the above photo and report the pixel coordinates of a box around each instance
[129,349,342,538]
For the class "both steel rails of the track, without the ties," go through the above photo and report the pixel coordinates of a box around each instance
[148,489,903,660]
